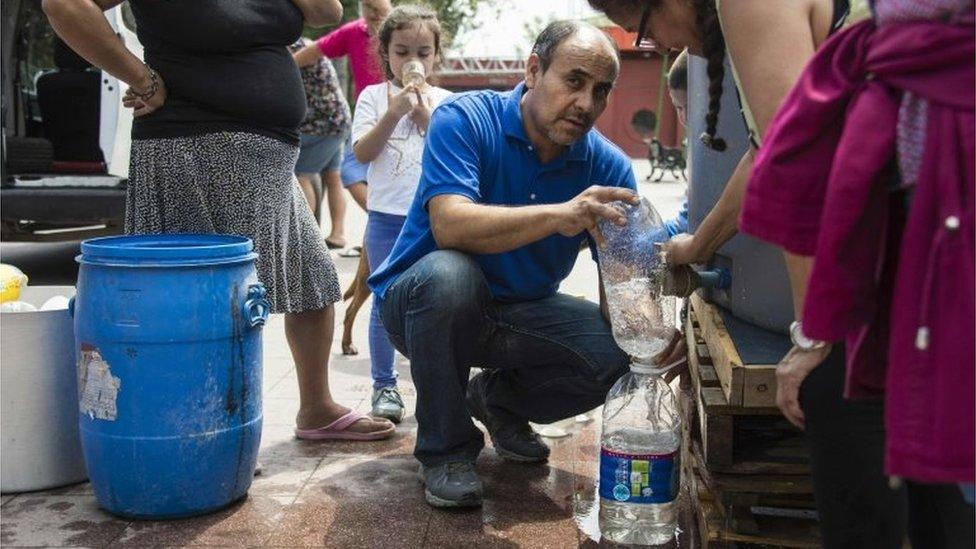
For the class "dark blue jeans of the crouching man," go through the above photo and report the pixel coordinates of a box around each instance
[382,250,630,467]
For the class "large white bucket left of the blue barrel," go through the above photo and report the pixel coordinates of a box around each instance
[0,286,88,493]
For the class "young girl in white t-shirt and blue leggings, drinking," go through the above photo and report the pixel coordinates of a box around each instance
[352,5,451,423]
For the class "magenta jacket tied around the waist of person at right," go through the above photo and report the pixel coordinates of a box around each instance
[741,19,976,482]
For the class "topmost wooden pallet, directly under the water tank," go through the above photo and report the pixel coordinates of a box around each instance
[690,293,776,408]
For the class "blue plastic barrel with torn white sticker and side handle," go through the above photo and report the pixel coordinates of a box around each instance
[72,234,269,518]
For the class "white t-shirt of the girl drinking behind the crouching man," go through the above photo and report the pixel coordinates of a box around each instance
[352,82,451,215]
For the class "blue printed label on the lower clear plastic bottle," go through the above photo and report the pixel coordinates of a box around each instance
[600,448,681,503]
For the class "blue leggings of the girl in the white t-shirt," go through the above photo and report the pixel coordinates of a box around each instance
[363,212,407,389]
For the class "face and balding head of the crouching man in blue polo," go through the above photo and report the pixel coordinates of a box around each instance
[525,30,619,146]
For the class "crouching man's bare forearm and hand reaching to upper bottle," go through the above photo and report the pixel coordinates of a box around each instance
[428,186,639,254]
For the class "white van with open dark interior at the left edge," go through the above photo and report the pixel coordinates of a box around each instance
[0,0,142,240]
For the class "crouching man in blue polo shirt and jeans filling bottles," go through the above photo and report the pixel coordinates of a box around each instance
[369,21,637,507]
